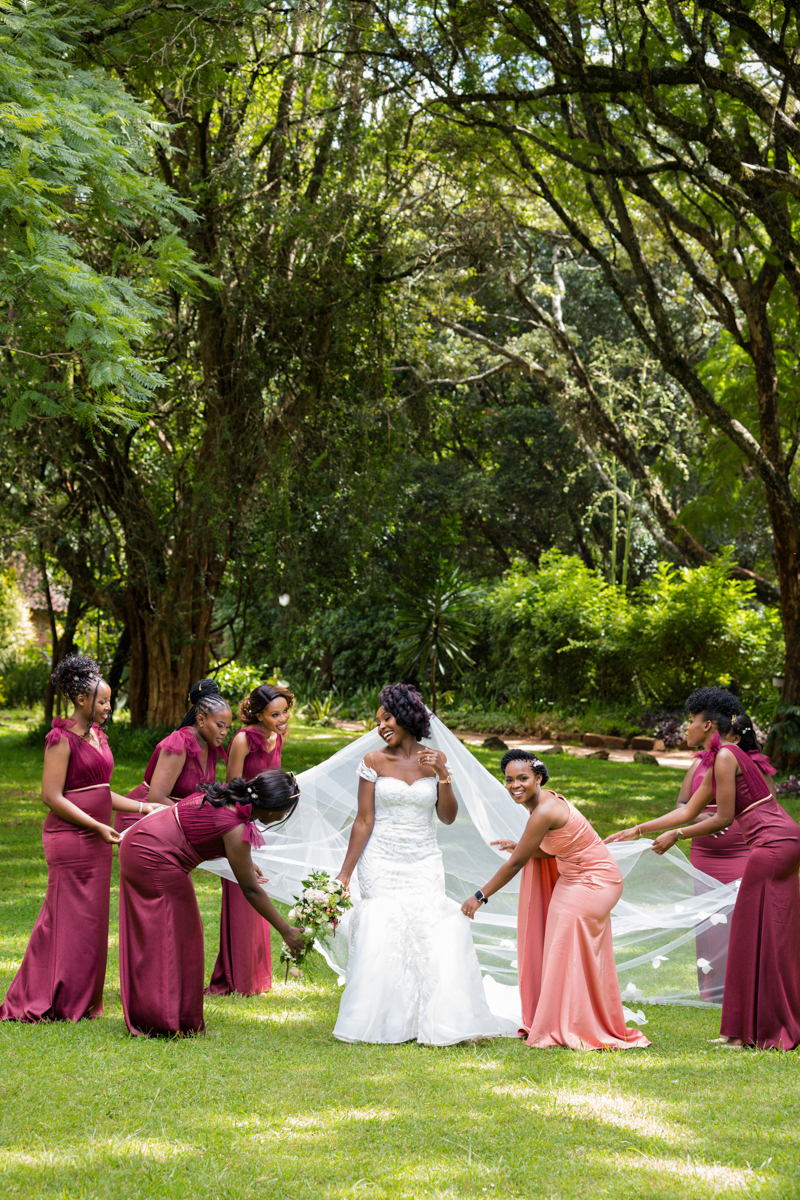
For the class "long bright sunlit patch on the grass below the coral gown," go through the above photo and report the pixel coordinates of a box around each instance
[492,1084,694,1146]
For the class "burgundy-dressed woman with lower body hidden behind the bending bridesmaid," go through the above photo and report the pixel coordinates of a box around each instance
[114,679,231,833]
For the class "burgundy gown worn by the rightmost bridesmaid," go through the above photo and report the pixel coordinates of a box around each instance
[706,743,800,1050]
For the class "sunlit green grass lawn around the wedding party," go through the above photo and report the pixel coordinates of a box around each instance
[0,716,800,1200]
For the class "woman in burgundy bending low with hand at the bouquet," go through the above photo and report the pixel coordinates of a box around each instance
[120,770,303,1036]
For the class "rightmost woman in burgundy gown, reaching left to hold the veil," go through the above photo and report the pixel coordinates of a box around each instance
[609,708,800,1050]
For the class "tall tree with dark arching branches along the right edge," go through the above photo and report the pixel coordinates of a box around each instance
[379,0,800,703]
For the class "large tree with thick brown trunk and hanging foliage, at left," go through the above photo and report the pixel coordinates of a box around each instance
[4,0,419,724]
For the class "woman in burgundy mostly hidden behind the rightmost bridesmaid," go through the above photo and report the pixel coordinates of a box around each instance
[663,688,750,1004]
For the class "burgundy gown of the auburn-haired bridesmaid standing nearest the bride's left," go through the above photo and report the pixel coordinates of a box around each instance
[206,725,283,996]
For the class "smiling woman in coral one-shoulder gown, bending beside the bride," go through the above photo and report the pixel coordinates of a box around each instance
[462,750,650,1050]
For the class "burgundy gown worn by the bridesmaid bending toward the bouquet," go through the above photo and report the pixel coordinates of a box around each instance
[120,794,263,1036]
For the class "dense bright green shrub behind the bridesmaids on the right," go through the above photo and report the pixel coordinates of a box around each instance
[487,551,783,708]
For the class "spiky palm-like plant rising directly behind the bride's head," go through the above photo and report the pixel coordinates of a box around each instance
[398,564,477,713]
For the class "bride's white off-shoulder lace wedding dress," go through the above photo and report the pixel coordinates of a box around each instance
[333,762,517,1046]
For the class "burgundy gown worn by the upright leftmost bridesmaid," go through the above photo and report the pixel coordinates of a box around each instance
[0,716,114,1021]
